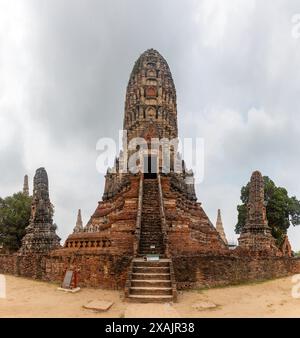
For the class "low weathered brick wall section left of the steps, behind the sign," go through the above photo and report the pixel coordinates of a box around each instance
[0,253,132,289]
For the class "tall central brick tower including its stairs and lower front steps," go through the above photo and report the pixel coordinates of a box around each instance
[64,49,227,300]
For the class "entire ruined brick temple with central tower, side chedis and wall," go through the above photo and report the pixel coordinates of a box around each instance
[0,49,300,302]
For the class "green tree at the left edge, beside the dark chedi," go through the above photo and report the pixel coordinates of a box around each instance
[0,192,31,252]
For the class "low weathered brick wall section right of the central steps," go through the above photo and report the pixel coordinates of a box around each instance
[173,255,300,289]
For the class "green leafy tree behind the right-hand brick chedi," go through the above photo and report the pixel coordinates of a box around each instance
[235,176,300,246]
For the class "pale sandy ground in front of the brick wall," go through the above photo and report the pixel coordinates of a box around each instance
[0,276,300,318]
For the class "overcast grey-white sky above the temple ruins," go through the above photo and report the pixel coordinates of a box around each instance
[0,0,300,250]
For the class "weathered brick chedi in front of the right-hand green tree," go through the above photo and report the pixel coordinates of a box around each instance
[239,171,279,254]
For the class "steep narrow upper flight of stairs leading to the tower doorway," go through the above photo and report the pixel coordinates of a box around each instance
[139,179,164,256]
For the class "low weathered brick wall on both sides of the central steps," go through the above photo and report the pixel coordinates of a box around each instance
[0,252,300,289]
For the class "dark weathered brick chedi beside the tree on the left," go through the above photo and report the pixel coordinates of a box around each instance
[20,168,60,254]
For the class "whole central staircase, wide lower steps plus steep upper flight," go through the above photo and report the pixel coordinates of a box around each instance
[125,178,177,303]
